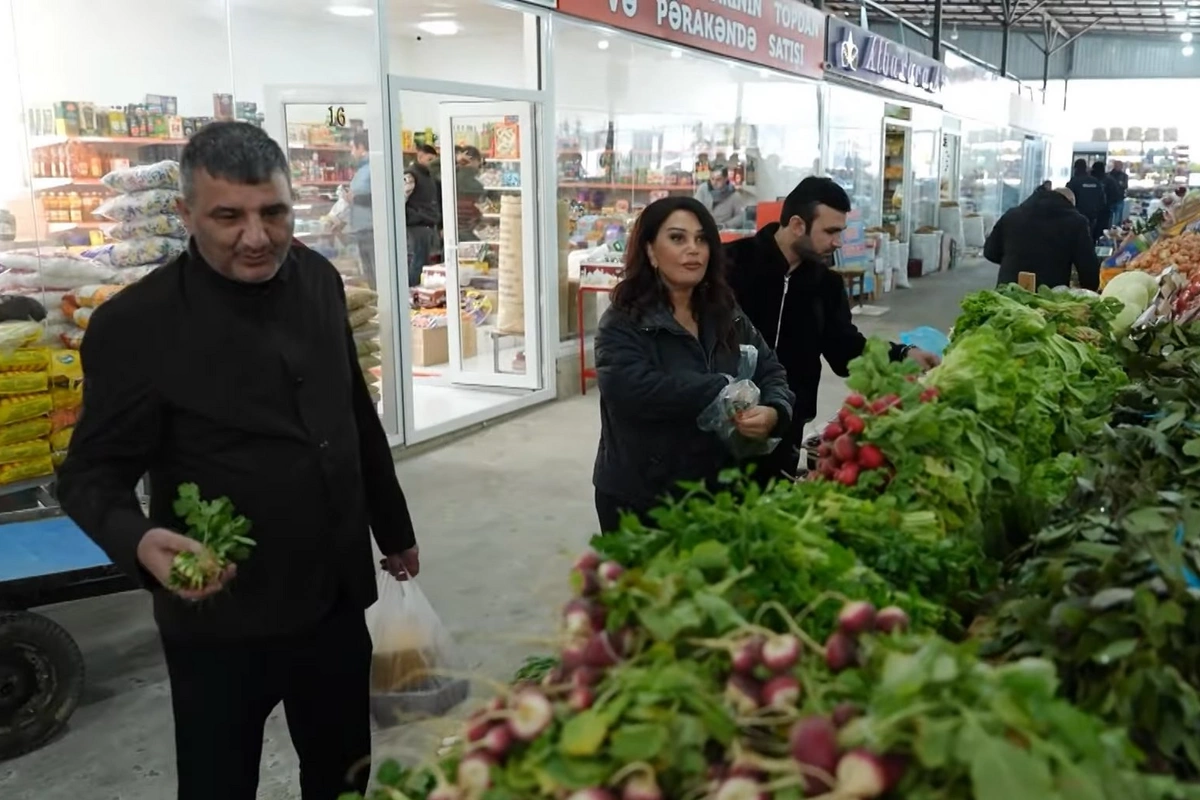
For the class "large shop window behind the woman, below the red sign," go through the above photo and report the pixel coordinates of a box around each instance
[554,19,820,338]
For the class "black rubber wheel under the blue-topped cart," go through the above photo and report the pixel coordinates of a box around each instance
[0,612,83,759]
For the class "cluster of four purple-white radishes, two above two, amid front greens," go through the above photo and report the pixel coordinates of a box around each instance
[725,633,802,715]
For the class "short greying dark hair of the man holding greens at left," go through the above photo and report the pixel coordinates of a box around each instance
[179,122,289,199]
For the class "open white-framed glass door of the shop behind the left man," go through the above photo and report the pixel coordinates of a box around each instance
[439,101,541,389]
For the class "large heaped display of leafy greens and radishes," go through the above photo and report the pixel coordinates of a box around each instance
[345,272,1200,800]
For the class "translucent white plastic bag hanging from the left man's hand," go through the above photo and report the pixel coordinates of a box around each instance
[367,572,469,727]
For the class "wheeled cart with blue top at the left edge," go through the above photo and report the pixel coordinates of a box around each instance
[0,477,134,760]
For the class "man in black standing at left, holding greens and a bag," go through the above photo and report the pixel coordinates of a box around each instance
[59,122,420,800]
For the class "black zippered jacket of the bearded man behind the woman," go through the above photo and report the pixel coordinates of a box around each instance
[725,223,904,431]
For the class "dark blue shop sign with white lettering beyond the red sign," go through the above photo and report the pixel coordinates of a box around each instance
[826,17,946,97]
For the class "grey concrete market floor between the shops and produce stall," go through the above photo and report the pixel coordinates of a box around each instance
[0,263,996,800]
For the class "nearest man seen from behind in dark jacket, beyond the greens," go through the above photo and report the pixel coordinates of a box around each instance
[983,190,1100,290]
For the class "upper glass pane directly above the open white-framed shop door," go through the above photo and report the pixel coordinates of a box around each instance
[388,0,540,89]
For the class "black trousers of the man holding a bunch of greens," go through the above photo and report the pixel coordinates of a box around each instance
[163,607,371,800]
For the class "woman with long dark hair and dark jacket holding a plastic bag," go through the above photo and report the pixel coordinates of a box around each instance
[593,197,794,531]
